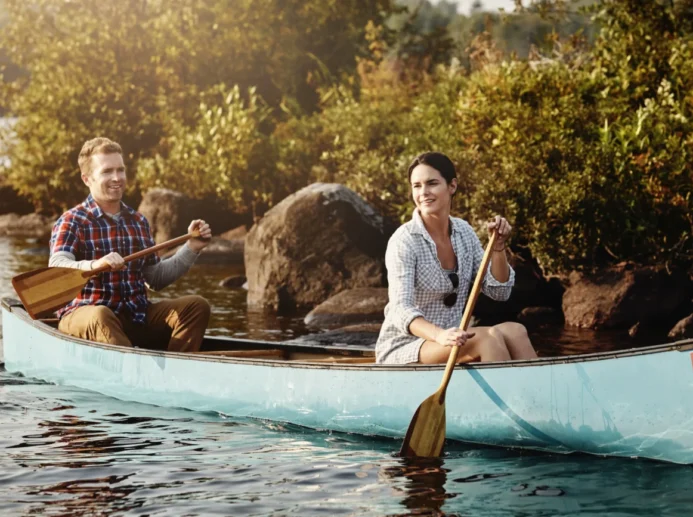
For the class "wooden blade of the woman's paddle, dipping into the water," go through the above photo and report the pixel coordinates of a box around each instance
[399,392,445,458]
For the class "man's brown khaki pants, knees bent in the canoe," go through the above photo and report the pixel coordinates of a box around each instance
[58,296,211,352]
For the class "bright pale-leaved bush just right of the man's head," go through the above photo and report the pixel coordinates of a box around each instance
[138,85,278,217]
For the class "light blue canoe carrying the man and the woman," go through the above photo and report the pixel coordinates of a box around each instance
[2,298,693,464]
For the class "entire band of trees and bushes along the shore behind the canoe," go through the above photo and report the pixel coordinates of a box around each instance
[0,0,693,337]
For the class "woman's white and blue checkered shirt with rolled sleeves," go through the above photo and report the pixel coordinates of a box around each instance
[375,210,515,364]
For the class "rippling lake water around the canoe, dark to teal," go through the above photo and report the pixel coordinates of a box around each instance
[0,238,693,516]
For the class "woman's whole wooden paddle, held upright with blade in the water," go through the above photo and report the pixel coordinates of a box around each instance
[399,231,497,458]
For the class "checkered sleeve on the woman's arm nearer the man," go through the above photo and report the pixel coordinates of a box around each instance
[385,234,423,334]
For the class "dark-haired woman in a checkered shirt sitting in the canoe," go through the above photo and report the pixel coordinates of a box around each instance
[376,153,537,364]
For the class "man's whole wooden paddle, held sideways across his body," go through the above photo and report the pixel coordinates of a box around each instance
[12,230,200,319]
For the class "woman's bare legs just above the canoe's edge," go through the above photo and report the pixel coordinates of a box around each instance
[419,327,511,364]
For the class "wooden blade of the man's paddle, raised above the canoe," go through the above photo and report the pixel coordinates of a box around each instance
[12,267,89,319]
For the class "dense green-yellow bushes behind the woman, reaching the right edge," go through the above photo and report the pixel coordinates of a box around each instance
[274,0,693,271]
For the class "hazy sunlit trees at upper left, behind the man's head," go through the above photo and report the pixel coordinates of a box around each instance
[0,0,398,211]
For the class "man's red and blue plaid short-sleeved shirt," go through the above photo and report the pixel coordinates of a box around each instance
[50,194,159,323]
